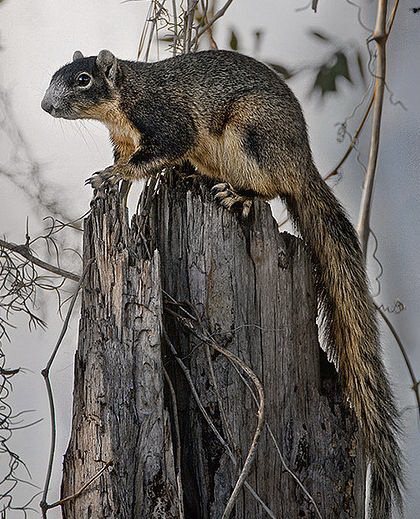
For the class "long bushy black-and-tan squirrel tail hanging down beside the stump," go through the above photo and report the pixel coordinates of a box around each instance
[285,164,402,519]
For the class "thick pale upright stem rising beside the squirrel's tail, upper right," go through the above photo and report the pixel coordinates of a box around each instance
[357,0,387,258]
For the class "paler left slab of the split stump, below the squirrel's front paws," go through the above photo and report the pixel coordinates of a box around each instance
[62,196,178,519]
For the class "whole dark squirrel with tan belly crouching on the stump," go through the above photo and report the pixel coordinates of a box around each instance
[41,50,403,519]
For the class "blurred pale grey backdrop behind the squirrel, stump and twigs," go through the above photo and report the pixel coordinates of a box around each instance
[0,0,420,519]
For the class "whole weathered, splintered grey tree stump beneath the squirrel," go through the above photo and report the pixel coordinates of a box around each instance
[62,169,365,519]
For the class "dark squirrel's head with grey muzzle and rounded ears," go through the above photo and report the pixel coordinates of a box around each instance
[41,50,122,120]
